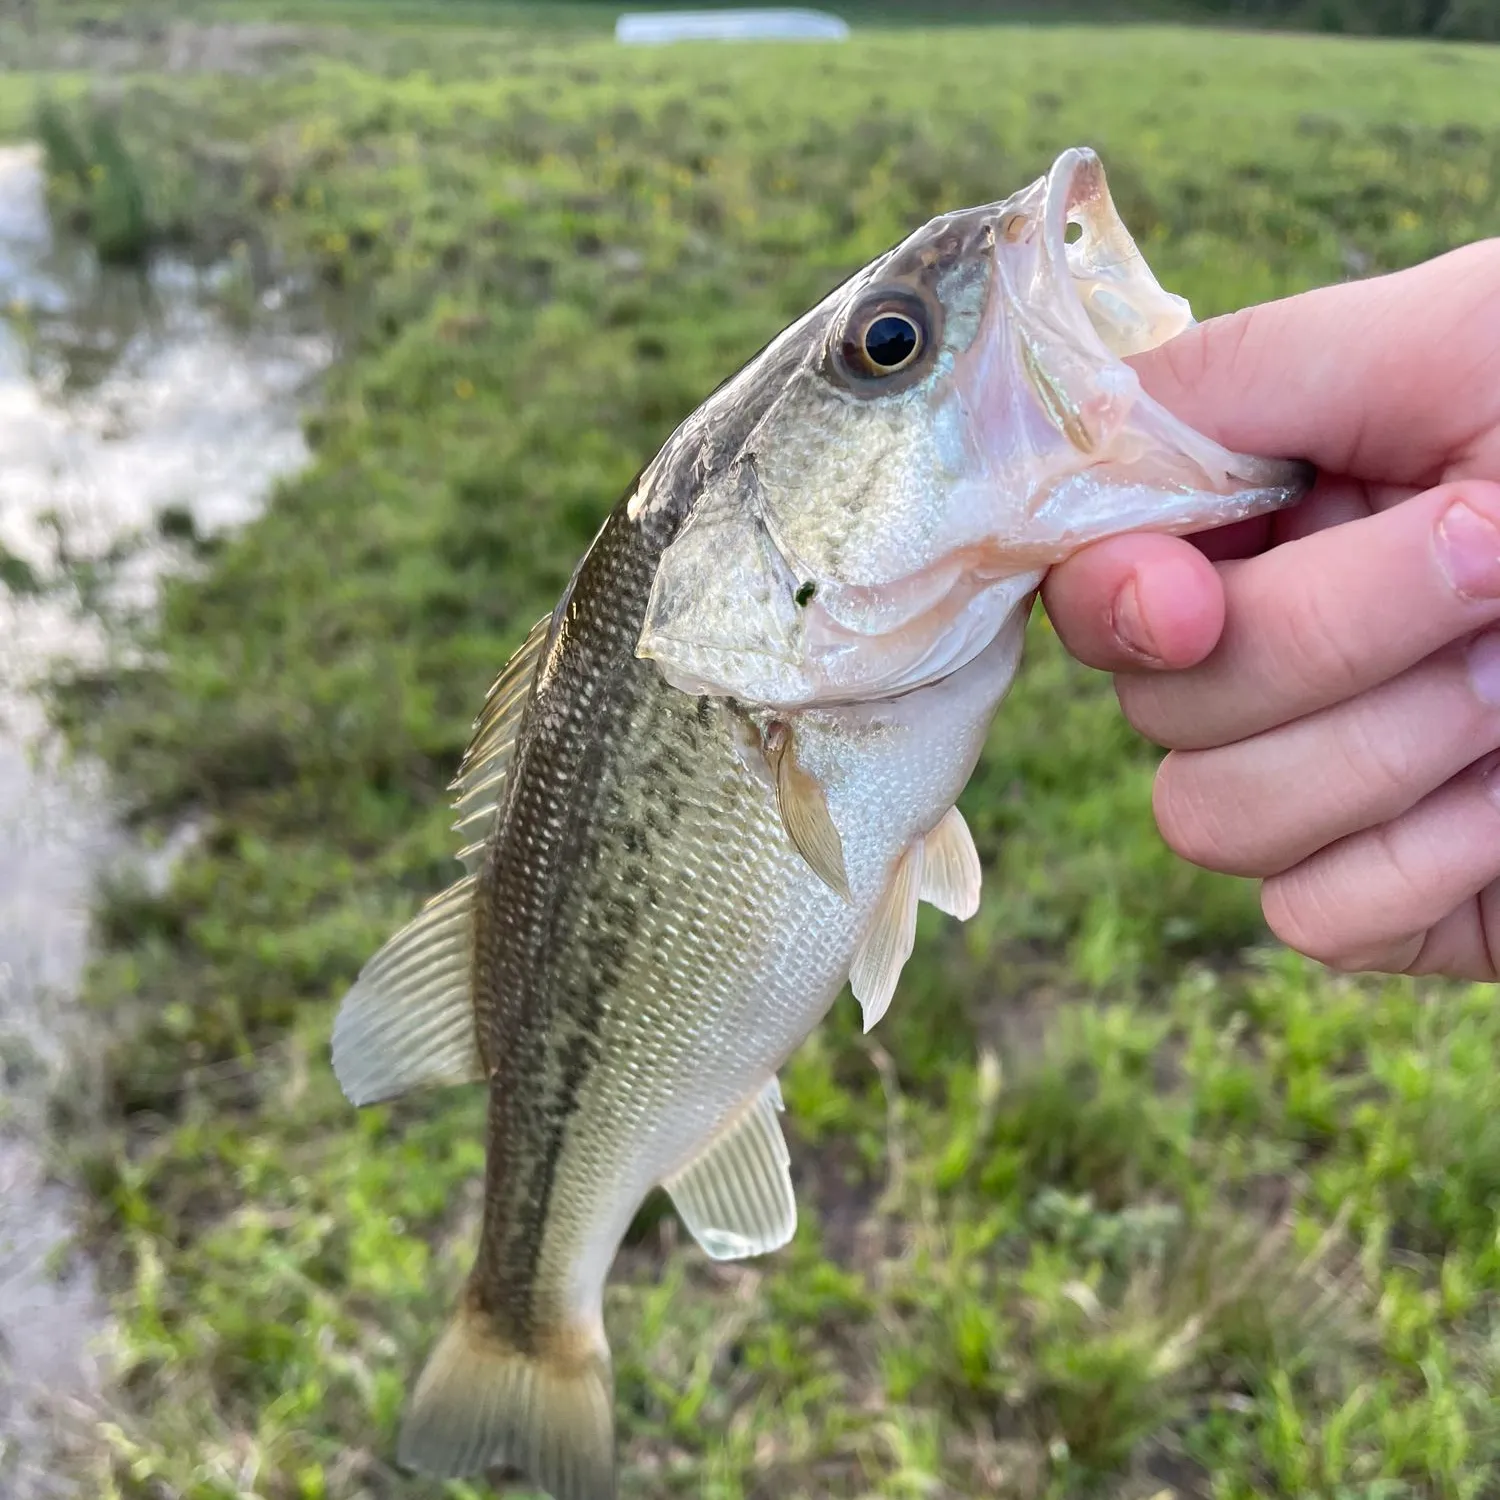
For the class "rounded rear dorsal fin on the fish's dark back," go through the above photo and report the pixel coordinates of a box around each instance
[333,875,485,1104]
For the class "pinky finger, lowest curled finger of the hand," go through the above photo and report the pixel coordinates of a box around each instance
[1262,756,1500,977]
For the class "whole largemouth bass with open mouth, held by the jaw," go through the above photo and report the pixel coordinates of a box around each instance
[332,147,1313,1500]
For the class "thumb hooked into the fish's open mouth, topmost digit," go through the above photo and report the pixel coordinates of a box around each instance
[1130,239,1500,488]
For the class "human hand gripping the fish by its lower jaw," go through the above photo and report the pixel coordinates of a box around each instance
[1043,240,1500,980]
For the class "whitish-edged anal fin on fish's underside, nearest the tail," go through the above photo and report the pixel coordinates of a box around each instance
[663,1077,797,1260]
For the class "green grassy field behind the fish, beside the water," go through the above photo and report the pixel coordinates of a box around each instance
[0,8,1500,1500]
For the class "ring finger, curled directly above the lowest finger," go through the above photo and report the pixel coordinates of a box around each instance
[1155,629,1500,876]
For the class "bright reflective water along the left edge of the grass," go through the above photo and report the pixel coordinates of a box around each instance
[0,146,332,1500]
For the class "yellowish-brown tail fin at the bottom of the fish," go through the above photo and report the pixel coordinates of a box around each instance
[398,1298,617,1500]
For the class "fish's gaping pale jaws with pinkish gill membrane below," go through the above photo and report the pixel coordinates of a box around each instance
[762,149,1314,699]
